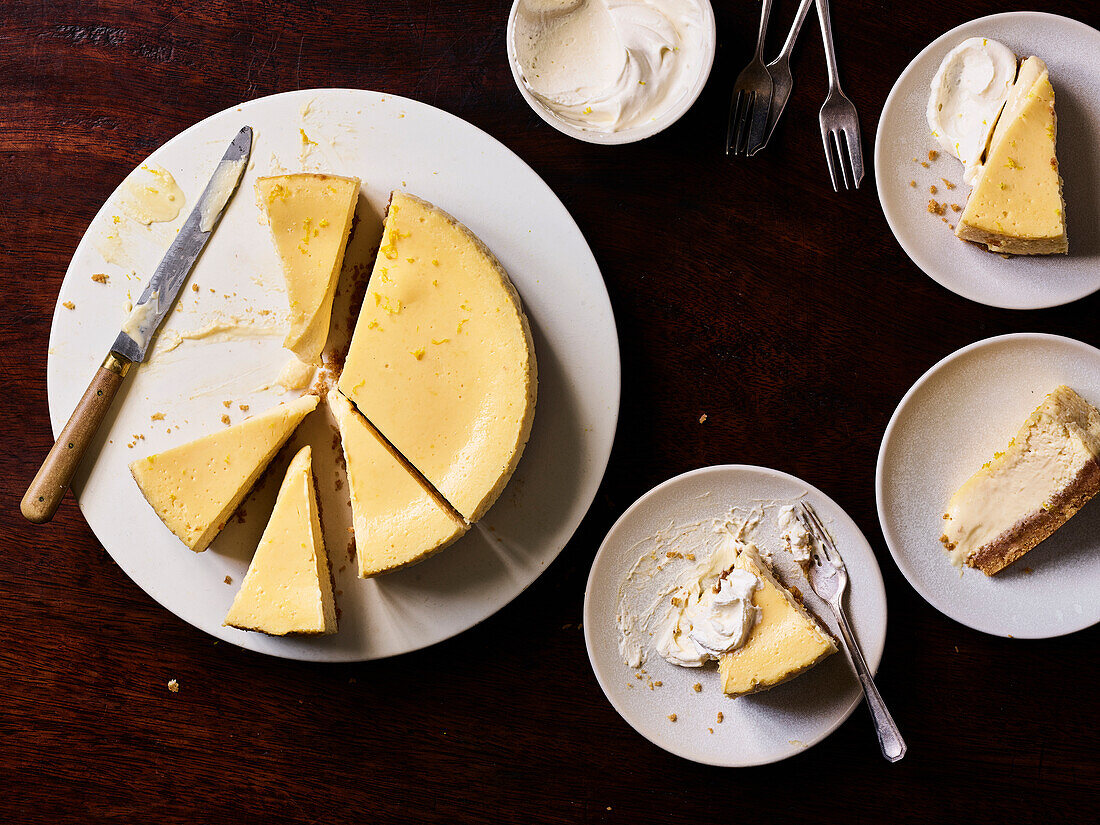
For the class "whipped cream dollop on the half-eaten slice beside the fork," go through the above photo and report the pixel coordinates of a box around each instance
[653,534,760,668]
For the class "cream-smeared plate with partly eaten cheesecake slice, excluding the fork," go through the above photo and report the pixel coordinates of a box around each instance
[584,464,887,767]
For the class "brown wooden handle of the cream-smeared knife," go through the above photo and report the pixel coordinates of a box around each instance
[20,352,130,525]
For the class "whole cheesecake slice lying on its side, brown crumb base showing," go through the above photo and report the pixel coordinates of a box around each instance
[939,386,1100,575]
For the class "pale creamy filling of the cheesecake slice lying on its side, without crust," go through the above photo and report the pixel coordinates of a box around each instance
[941,385,1100,567]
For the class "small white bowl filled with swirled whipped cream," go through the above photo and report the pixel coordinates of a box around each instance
[507,0,716,144]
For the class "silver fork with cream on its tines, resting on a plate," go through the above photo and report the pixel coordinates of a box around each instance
[794,502,908,762]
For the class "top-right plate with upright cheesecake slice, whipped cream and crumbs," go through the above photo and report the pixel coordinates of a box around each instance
[875,12,1100,309]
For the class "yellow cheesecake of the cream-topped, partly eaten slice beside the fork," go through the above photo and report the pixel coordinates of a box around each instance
[718,546,837,696]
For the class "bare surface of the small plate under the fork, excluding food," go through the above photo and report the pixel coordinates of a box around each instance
[584,464,887,768]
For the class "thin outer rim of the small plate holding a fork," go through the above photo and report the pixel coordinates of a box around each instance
[583,464,890,768]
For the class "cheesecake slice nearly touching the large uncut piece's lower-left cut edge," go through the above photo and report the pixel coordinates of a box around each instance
[328,389,470,578]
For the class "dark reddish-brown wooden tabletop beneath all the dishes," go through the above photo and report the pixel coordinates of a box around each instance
[0,0,1100,823]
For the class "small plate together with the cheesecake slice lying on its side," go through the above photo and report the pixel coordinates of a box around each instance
[876,333,1100,638]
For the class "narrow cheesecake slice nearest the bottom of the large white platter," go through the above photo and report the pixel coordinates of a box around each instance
[224,447,337,636]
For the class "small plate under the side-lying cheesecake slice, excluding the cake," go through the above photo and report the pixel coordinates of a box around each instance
[876,332,1100,638]
